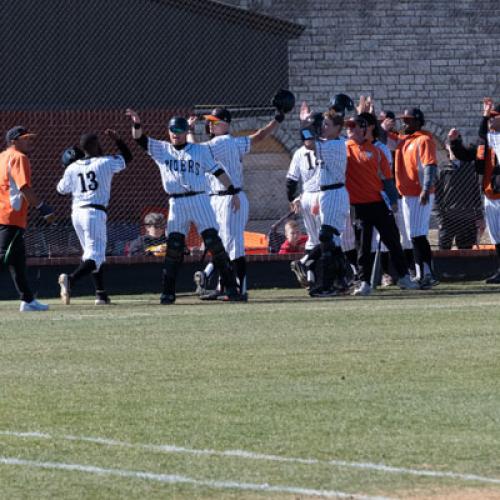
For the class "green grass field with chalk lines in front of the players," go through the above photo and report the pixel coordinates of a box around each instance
[0,284,500,500]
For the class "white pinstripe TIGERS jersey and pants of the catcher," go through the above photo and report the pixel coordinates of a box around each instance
[148,137,220,235]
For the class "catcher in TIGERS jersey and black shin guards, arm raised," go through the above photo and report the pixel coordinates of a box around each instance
[127,109,242,305]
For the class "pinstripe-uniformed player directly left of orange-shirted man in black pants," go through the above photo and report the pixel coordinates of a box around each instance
[301,113,349,297]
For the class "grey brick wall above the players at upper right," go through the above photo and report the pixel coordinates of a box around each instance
[222,0,500,145]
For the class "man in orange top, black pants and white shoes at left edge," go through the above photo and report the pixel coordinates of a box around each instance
[0,125,54,312]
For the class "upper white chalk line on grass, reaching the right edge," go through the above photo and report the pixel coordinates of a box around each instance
[0,431,500,484]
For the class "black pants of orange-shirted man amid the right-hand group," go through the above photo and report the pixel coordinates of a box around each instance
[354,201,408,283]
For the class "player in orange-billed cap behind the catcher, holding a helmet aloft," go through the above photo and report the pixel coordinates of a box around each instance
[188,98,285,300]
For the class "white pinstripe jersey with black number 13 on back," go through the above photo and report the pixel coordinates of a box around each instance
[57,155,125,208]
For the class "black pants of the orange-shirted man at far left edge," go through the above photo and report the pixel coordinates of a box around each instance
[0,224,34,302]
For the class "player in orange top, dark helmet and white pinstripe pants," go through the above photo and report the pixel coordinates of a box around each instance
[395,108,437,289]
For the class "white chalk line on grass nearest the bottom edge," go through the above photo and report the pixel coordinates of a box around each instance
[0,456,389,500]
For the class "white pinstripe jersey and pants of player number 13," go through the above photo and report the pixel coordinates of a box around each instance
[57,155,125,269]
